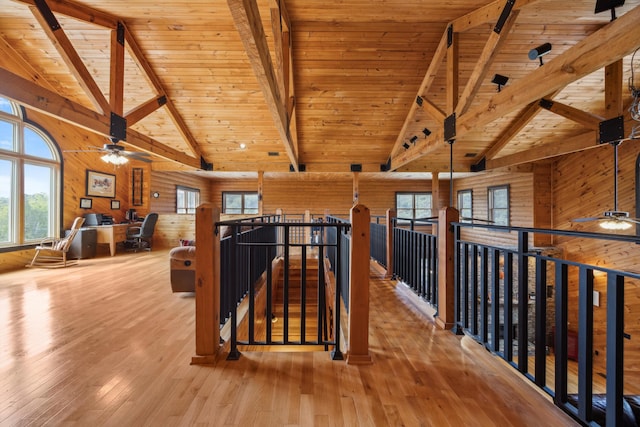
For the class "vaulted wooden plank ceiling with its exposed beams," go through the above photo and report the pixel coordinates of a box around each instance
[0,0,640,177]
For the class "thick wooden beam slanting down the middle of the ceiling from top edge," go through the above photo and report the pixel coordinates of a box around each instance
[227,0,299,172]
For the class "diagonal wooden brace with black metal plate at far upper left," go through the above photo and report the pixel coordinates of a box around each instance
[29,0,110,113]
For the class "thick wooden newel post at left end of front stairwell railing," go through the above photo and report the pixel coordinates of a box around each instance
[191,203,220,364]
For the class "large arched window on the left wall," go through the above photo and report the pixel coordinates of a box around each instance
[0,98,61,248]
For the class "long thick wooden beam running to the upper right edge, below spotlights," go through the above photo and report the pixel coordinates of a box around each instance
[392,6,640,168]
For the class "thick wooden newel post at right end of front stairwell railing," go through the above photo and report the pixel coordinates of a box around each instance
[347,205,371,365]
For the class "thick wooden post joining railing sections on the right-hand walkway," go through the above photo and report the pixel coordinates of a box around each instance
[436,206,459,329]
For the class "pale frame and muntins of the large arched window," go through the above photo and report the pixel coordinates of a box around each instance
[0,98,63,251]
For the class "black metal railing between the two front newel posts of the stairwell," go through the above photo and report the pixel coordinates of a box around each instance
[217,220,350,359]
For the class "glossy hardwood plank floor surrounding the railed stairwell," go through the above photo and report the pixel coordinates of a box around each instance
[0,251,575,426]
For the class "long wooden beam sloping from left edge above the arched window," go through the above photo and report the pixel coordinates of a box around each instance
[0,68,201,168]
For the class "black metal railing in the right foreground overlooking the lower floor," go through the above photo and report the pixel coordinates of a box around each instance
[452,223,640,427]
